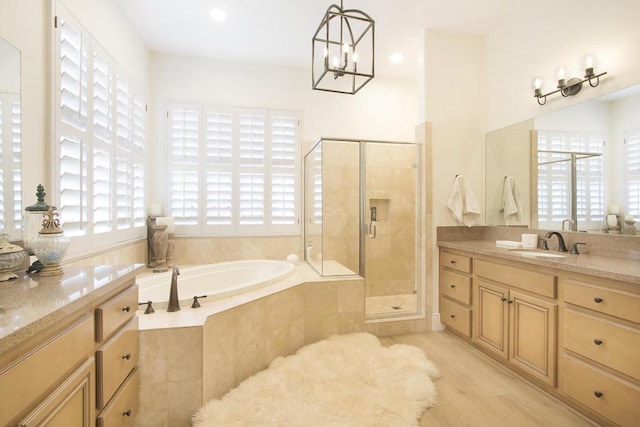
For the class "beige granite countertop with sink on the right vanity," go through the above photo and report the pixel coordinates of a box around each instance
[438,240,640,285]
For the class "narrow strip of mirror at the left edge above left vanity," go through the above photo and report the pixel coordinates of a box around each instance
[0,37,22,240]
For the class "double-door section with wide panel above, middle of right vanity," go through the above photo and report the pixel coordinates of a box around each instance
[474,260,558,386]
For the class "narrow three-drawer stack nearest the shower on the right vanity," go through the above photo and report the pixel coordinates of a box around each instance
[440,252,472,338]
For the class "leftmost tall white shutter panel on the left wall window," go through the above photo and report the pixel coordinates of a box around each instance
[56,8,90,236]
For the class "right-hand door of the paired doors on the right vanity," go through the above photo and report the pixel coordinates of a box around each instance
[508,291,558,387]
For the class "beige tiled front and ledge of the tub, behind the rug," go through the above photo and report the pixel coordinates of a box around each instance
[136,263,364,427]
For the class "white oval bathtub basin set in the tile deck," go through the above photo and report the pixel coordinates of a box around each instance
[137,260,294,307]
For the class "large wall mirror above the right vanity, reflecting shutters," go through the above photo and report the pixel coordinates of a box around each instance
[485,85,640,235]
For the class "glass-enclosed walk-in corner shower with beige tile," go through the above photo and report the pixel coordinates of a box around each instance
[304,138,423,319]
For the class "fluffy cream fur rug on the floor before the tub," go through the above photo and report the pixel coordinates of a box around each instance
[193,333,438,427]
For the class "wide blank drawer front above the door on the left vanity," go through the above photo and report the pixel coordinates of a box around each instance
[0,316,94,425]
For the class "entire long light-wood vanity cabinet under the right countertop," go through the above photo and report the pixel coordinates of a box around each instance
[440,247,640,426]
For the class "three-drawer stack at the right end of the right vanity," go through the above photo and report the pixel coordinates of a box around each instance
[561,277,640,426]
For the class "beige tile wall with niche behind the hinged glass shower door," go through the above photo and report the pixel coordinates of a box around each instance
[365,144,416,296]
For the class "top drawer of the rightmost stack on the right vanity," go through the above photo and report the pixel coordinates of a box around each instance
[564,280,640,323]
